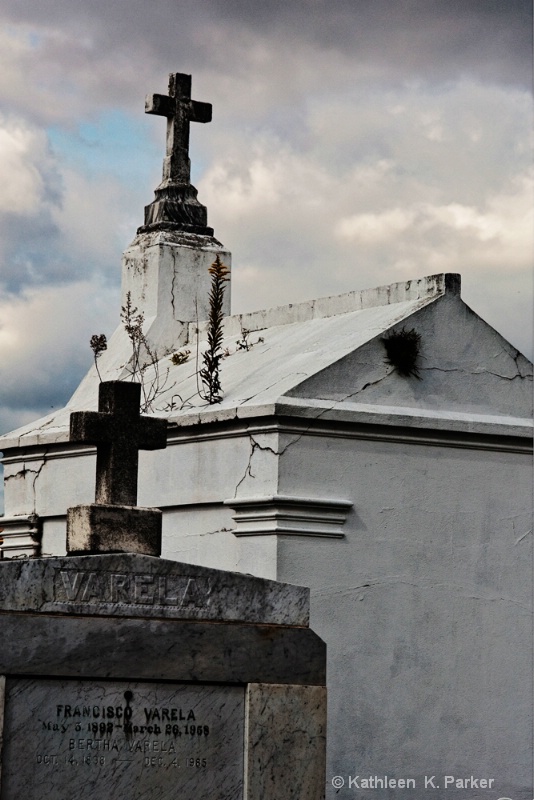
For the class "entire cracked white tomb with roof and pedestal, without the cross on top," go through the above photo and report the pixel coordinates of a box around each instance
[0,70,533,800]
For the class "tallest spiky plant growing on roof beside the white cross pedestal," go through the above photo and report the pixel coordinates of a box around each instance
[199,254,230,403]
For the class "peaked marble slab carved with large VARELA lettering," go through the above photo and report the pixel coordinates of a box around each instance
[0,554,309,627]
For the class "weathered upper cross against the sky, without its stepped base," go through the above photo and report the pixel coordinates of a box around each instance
[145,72,215,184]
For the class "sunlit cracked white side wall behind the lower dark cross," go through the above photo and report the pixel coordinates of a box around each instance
[31,426,278,577]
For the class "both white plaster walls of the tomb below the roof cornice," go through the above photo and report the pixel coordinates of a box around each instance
[3,390,532,800]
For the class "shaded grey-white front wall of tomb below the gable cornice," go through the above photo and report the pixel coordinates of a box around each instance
[277,432,533,800]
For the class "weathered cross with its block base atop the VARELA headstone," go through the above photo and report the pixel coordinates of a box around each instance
[67,381,167,556]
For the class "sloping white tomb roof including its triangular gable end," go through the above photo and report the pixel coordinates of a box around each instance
[0,274,532,450]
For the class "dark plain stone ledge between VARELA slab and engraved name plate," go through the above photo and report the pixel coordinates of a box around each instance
[0,612,326,686]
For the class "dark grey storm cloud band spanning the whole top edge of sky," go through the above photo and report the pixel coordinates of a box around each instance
[4,0,532,91]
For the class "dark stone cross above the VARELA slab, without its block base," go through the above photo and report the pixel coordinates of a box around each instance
[70,381,167,506]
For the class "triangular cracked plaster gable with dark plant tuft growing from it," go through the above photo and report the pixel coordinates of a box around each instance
[288,295,532,419]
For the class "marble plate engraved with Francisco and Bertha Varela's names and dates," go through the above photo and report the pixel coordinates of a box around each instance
[0,678,244,800]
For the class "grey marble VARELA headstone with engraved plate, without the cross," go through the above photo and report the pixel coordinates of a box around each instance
[0,553,326,800]
